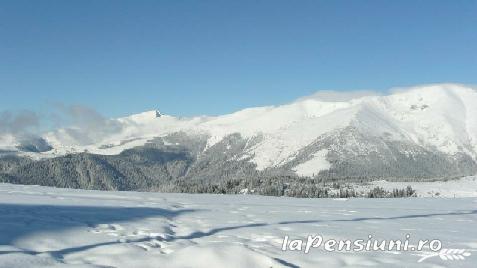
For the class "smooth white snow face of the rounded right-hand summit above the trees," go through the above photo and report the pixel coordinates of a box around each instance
[356,85,477,157]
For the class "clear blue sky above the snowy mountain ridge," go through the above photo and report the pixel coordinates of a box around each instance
[0,0,477,117]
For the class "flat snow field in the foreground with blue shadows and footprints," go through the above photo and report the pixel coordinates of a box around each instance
[0,184,477,268]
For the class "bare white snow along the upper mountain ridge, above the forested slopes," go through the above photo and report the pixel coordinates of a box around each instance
[6,84,477,170]
